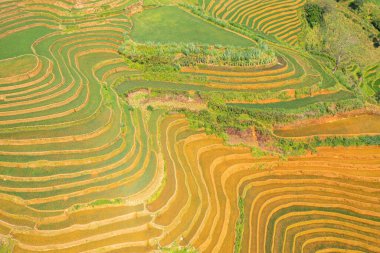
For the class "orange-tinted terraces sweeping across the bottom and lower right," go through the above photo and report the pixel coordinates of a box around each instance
[1,110,380,252]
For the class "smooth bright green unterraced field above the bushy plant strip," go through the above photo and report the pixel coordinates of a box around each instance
[132,6,252,46]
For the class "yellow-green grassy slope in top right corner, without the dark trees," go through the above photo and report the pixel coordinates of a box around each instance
[301,0,380,102]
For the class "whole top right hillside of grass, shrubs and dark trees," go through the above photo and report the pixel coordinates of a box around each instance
[300,0,380,103]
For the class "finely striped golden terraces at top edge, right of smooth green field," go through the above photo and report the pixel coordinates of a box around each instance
[201,0,305,45]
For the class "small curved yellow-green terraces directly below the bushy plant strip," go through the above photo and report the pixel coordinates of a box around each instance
[181,49,336,90]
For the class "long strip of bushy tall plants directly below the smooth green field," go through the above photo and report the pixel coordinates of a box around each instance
[120,40,277,70]
